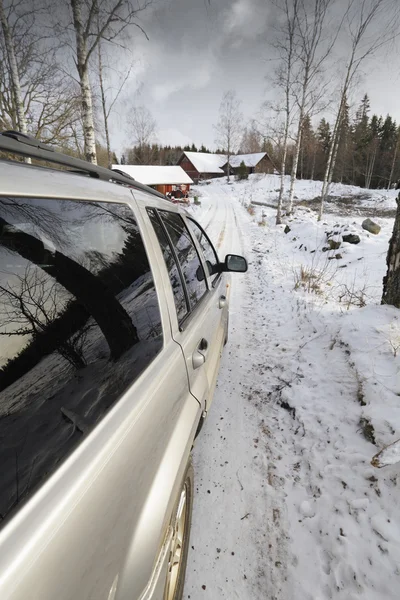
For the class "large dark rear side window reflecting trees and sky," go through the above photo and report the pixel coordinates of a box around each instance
[0,198,162,521]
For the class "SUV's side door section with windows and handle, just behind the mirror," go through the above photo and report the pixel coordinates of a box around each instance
[140,199,226,409]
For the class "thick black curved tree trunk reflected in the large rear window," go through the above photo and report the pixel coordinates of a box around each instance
[0,217,138,359]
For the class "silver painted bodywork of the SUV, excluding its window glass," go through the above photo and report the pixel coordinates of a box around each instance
[0,161,231,600]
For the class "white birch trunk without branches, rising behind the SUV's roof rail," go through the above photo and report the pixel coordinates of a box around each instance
[71,0,97,164]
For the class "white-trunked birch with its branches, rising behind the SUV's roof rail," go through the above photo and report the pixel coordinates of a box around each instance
[65,0,152,163]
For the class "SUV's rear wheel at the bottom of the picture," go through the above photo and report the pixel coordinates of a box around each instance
[164,460,194,600]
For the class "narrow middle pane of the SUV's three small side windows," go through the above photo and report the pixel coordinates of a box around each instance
[159,210,207,309]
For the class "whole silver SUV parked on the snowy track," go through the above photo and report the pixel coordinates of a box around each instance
[0,132,247,600]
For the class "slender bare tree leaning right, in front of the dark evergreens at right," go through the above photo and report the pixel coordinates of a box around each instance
[318,0,399,220]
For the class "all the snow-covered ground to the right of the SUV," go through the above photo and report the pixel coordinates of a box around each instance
[184,176,400,600]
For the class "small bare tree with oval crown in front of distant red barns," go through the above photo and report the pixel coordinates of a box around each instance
[215,90,243,182]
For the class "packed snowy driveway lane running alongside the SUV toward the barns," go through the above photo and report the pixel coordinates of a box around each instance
[185,188,292,600]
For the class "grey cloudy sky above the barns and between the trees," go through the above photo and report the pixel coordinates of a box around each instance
[108,0,400,152]
